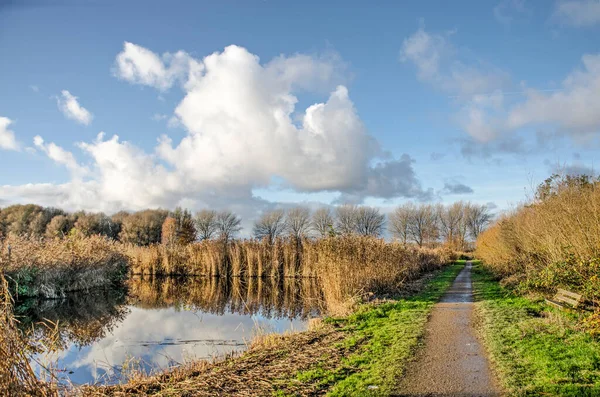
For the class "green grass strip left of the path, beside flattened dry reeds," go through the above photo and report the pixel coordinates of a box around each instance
[286,261,464,396]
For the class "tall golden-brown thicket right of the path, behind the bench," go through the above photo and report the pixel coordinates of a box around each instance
[476,179,600,299]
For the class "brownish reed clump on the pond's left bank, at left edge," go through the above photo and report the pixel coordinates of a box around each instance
[0,236,127,298]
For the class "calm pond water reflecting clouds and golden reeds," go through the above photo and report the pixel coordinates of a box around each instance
[16,278,322,384]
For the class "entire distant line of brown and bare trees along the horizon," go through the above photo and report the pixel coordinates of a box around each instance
[0,201,492,247]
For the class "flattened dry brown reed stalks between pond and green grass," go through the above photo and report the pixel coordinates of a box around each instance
[81,325,349,396]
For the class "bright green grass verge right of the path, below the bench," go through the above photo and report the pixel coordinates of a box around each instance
[472,266,600,396]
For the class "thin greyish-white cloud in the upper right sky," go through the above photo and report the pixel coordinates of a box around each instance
[401,28,600,148]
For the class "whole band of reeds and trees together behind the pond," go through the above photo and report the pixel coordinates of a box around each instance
[0,198,490,298]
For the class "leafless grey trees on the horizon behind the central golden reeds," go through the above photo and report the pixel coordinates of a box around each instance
[253,201,492,247]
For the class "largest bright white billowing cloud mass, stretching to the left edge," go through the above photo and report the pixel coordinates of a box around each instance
[0,43,427,217]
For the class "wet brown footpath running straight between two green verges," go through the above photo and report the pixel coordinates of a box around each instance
[398,262,501,397]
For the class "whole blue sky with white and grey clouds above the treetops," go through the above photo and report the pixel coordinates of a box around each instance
[0,0,600,227]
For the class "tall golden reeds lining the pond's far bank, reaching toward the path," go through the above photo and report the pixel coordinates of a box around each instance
[125,236,454,310]
